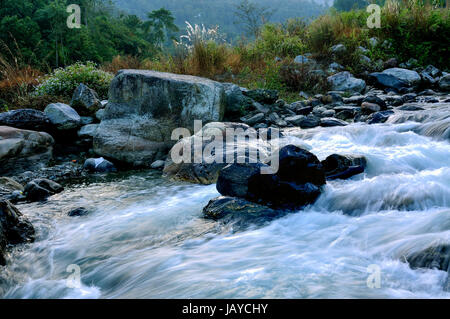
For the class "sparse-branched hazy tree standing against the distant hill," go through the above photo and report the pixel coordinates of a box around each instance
[235,0,275,38]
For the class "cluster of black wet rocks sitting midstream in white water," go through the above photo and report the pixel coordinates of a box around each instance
[203,145,366,223]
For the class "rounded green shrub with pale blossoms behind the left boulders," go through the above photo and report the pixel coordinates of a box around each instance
[34,62,114,98]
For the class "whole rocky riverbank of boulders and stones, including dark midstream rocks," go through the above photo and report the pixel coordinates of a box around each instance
[0,59,450,288]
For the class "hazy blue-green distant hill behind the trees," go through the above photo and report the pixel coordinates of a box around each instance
[113,0,332,38]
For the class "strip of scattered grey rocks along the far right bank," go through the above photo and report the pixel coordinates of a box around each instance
[234,65,450,129]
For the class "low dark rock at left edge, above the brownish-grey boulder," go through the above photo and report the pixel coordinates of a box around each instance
[0,109,52,131]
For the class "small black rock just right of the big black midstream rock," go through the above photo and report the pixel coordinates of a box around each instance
[322,154,367,180]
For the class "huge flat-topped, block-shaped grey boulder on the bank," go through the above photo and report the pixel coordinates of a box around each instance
[93,70,225,167]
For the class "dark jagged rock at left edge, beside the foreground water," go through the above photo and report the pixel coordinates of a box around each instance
[0,200,35,265]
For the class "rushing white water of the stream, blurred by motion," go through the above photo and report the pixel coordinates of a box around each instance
[0,105,450,298]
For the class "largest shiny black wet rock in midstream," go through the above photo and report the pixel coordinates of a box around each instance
[216,145,325,209]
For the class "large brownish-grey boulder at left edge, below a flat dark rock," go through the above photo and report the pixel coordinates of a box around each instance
[0,126,54,174]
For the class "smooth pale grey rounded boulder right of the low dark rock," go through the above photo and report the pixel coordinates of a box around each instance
[44,103,81,130]
